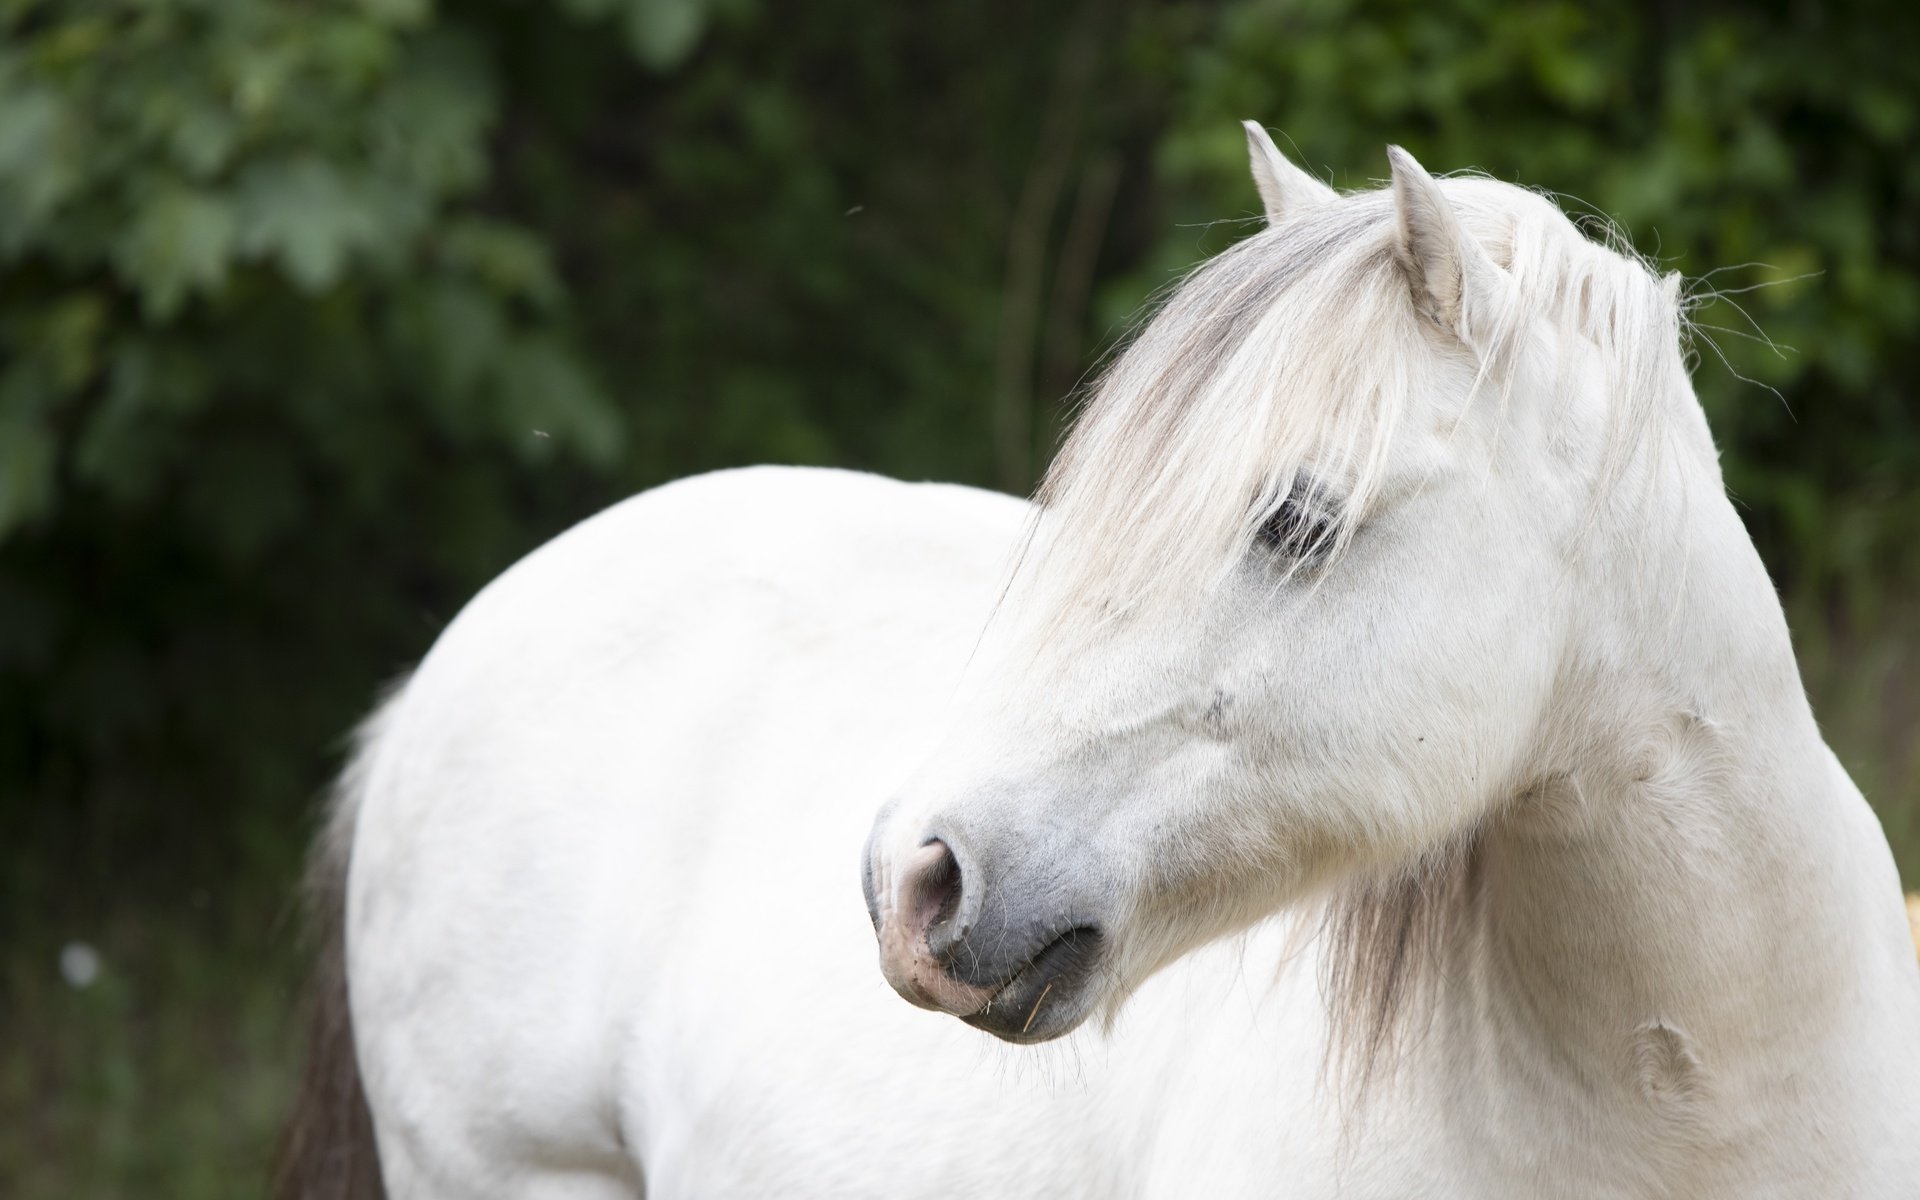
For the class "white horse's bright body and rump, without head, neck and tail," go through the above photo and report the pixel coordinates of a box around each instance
[349,462,1905,1198]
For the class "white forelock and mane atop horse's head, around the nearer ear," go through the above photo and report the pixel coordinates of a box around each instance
[1023,179,1682,639]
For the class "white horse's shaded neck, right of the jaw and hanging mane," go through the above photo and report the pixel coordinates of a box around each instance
[1444,432,1920,1159]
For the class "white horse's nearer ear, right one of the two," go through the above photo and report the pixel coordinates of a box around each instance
[1386,146,1501,346]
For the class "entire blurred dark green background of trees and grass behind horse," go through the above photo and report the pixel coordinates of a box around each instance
[0,0,1920,1196]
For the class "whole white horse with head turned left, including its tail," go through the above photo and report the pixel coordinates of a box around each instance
[286,127,1920,1200]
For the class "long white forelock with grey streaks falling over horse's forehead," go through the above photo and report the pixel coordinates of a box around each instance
[1025,204,1405,634]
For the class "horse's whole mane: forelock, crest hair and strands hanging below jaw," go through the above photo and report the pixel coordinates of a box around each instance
[1014,177,1697,1098]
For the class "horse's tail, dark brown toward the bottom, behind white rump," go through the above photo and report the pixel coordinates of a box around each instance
[273,687,399,1200]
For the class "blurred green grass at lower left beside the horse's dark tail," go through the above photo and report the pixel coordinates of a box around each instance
[0,889,301,1200]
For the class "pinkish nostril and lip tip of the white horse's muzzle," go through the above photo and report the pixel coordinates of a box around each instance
[868,837,993,1016]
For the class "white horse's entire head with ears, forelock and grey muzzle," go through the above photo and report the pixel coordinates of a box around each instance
[864,125,1689,1043]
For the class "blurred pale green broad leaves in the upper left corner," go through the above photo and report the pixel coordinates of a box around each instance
[0,2,622,522]
